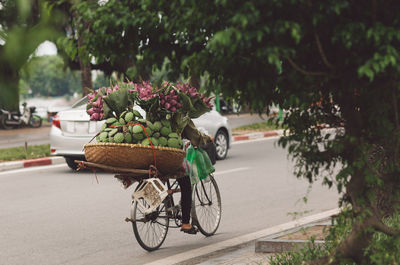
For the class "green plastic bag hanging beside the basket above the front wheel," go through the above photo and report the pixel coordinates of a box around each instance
[186,146,215,184]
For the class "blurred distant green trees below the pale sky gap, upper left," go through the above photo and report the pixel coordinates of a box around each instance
[21,55,81,96]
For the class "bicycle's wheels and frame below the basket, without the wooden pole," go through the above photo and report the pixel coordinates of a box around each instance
[131,172,222,251]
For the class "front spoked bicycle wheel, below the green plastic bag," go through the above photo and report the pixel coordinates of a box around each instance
[192,175,222,236]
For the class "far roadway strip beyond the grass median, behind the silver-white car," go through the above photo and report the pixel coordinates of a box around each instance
[0,114,266,149]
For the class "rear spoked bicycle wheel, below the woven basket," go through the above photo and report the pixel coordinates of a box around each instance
[131,199,169,251]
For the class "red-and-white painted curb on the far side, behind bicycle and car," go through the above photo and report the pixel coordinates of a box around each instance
[0,130,283,172]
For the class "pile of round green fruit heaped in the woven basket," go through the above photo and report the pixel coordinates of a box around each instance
[96,110,182,148]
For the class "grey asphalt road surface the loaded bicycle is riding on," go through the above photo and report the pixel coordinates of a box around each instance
[0,139,338,265]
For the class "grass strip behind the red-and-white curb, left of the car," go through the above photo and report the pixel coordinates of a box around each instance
[0,144,50,161]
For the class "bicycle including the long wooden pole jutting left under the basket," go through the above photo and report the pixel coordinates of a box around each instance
[75,160,222,251]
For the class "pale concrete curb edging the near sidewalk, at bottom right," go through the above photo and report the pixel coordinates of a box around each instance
[146,208,340,265]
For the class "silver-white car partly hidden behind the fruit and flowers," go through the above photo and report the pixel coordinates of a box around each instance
[50,97,232,170]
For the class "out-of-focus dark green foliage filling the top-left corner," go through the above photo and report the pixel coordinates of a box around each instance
[0,0,63,110]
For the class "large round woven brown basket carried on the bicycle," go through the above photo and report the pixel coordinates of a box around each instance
[84,143,186,174]
